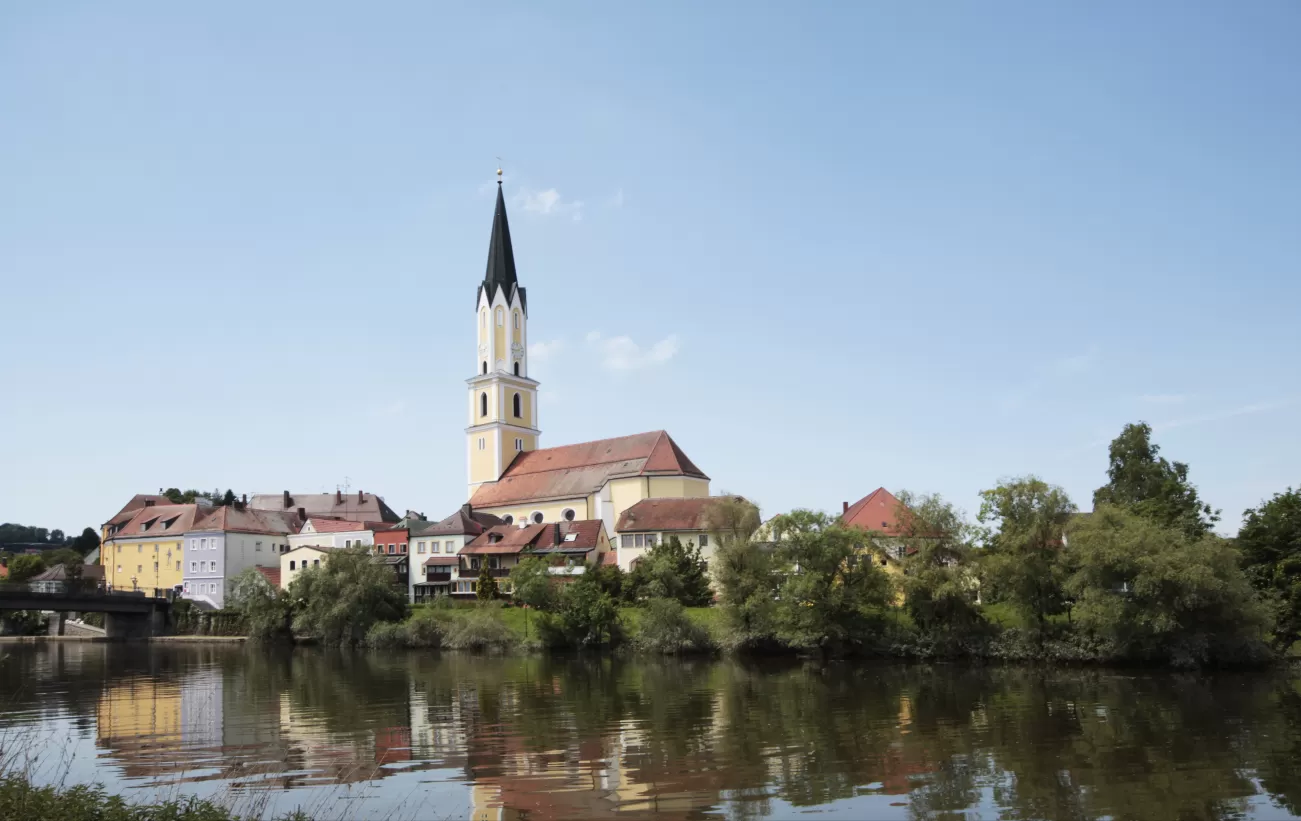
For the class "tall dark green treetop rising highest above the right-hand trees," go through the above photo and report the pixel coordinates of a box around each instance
[1093,422,1220,539]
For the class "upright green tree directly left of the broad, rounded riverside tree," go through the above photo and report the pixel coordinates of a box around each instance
[977,476,1076,632]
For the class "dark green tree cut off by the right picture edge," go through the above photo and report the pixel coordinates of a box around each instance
[1237,488,1301,648]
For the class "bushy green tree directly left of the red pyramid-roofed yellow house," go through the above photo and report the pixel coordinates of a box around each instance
[773,510,894,652]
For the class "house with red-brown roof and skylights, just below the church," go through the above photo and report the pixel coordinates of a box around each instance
[451,519,610,597]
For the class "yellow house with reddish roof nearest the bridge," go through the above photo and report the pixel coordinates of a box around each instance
[99,505,202,591]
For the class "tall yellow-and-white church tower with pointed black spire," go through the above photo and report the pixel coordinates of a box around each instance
[466,168,541,496]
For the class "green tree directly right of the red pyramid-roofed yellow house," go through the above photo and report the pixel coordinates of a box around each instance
[896,491,986,652]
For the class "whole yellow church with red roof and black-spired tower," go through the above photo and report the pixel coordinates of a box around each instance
[466,169,709,537]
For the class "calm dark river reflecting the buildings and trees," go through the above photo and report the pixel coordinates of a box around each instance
[0,643,1301,821]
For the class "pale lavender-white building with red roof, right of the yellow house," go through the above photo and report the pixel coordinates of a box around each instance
[181,502,303,609]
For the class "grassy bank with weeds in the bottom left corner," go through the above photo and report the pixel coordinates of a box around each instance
[0,773,308,821]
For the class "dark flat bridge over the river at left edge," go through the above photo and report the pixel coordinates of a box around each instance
[0,582,172,639]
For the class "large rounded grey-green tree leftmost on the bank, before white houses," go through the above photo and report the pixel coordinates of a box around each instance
[289,548,407,644]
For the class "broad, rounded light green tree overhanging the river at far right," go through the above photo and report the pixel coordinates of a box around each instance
[1067,505,1268,666]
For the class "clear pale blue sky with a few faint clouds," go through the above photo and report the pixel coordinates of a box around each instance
[0,0,1301,533]
